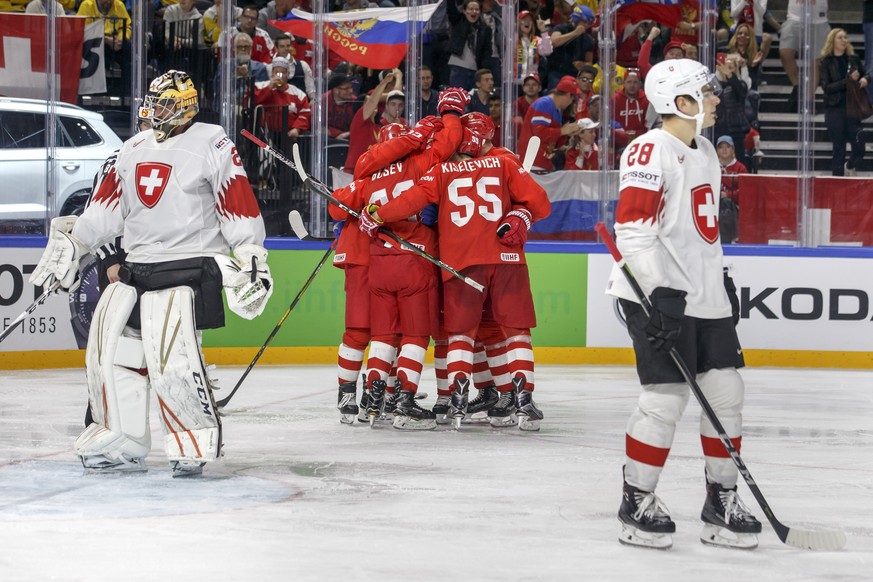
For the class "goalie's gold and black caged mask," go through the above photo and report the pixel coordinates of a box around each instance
[139,70,200,142]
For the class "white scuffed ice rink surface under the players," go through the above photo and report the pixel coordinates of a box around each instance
[0,366,873,582]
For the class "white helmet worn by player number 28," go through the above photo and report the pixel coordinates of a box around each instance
[646,59,721,133]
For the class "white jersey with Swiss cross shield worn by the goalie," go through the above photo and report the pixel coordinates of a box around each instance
[73,123,266,263]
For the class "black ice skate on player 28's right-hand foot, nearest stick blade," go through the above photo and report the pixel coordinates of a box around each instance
[700,483,761,550]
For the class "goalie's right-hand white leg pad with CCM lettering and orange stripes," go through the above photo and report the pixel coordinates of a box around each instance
[140,287,221,465]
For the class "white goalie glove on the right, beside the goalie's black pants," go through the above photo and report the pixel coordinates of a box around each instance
[215,244,273,319]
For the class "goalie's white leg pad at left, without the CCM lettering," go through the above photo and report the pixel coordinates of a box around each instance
[76,283,151,470]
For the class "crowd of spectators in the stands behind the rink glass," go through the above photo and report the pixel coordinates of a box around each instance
[0,0,873,240]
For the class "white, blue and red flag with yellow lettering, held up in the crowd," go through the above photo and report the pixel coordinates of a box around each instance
[270,4,437,69]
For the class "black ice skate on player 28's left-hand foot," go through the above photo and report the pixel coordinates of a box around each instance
[618,482,676,550]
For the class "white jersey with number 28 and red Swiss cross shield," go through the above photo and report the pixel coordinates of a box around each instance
[607,130,731,319]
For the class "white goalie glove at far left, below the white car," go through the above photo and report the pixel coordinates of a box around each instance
[28,216,88,292]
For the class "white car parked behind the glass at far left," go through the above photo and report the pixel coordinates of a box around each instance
[0,97,122,232]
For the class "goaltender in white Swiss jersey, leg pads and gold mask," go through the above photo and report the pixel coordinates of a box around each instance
[30,70,273,476]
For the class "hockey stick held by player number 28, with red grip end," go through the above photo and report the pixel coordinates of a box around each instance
[594,222,846,550]
